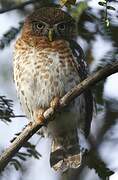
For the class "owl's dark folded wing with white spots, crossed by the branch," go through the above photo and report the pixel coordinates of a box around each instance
[70,40,93,137]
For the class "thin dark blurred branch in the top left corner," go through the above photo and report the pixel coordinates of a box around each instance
[0,0,38,14]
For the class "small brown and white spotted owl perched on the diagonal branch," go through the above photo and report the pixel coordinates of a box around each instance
[13,6,93,171]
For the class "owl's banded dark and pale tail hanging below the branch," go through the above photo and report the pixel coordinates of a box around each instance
[50,141,82,172]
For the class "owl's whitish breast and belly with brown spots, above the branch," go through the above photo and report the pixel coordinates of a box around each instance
[14,38,80,117]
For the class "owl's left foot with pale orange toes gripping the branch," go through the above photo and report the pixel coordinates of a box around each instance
[35,108,45,124]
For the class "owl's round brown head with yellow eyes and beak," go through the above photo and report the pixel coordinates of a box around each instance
[24,6,76,41]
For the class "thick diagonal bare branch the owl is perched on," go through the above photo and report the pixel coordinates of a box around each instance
[0,62,118,171]
